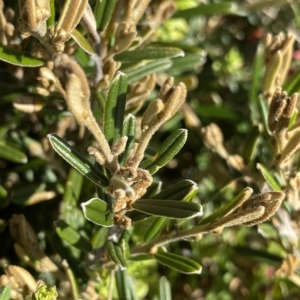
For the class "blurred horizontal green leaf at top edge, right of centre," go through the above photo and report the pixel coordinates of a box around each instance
[172,1,247,19]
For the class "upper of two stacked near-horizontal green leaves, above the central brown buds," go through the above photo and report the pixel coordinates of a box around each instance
[114,47,184,63]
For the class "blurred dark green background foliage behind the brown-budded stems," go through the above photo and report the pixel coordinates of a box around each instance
[0,0,300,300]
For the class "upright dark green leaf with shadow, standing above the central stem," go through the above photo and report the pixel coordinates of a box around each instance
[104,72,127,143]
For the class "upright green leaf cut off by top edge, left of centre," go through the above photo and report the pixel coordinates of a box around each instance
[95,0,118,31]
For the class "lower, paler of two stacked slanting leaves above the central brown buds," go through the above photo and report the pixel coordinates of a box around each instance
[124,59,172,84]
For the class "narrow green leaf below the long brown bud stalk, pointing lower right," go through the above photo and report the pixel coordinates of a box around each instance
[153,252,202,274]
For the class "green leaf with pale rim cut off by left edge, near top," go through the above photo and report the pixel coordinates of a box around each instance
[0,46,44,67]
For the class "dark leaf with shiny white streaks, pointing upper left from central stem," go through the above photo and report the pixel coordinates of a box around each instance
[47,134,109,187]
